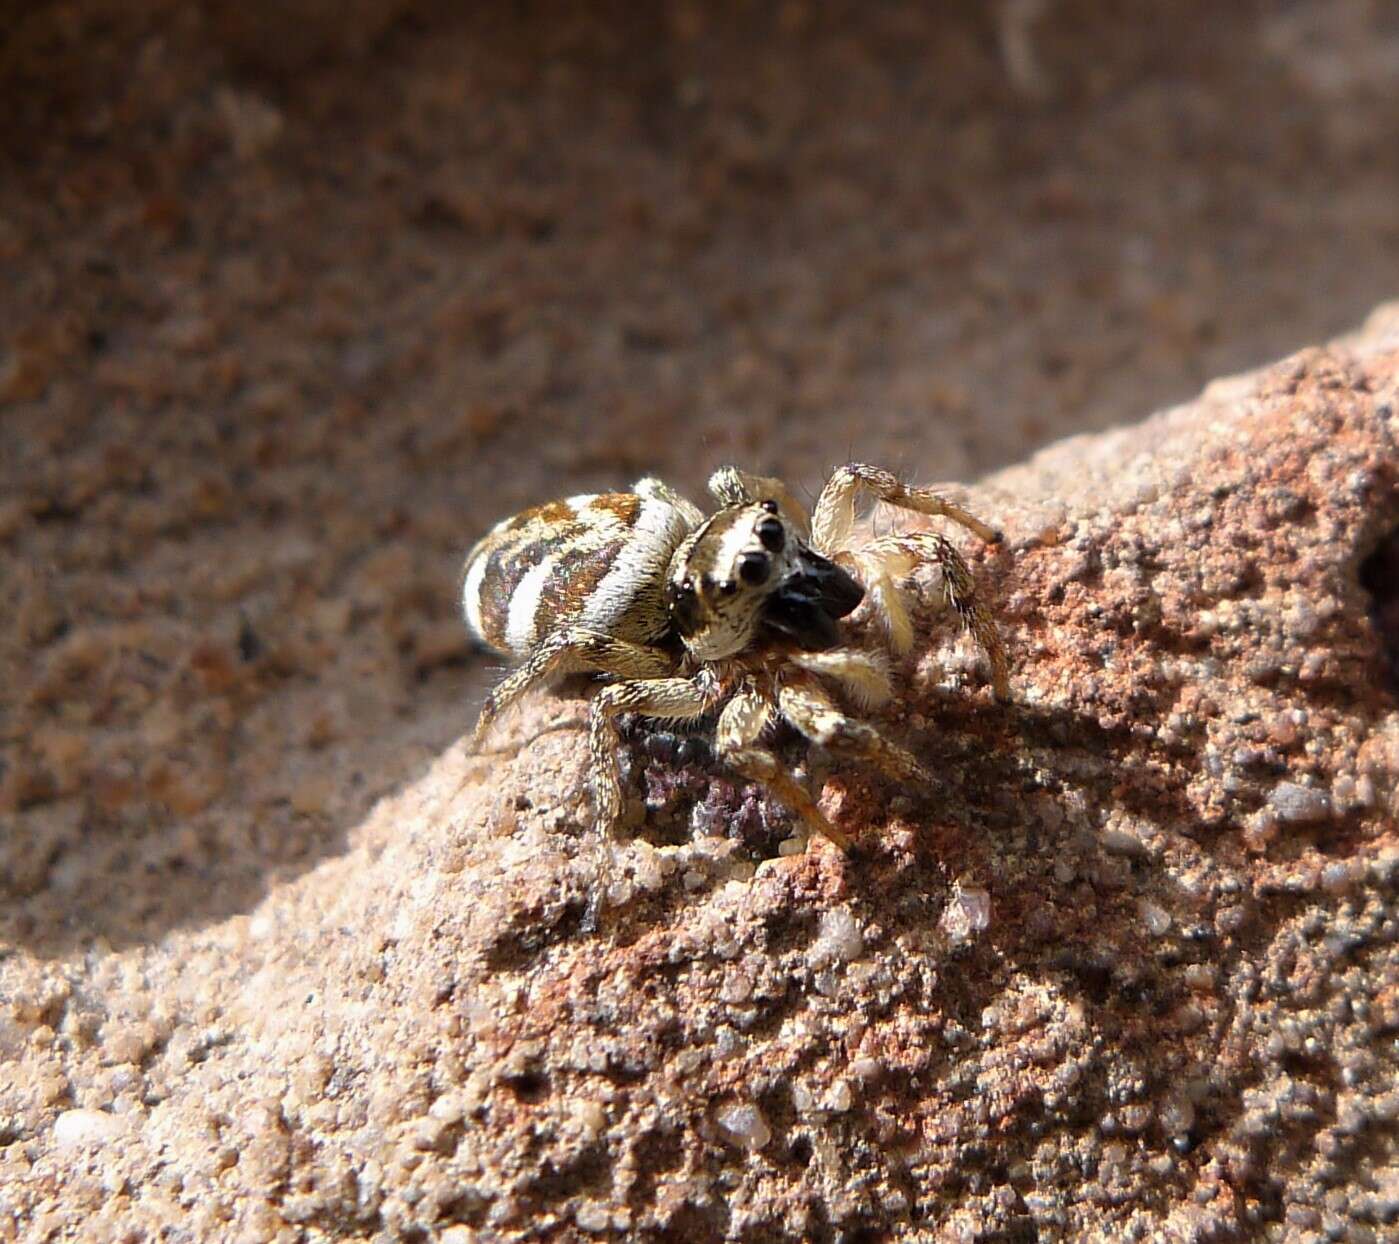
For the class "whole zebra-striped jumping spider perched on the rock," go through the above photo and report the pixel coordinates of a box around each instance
[462,463,1007,848]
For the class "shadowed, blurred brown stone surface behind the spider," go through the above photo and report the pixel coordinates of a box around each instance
[0,0,1399,957]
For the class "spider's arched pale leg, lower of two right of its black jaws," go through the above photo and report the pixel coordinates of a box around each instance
[855,532,1010,700]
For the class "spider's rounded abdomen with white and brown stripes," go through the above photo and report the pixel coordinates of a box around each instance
[462,493,693,658]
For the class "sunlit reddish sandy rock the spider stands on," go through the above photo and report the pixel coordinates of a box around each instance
[8,311,1399,1240]
